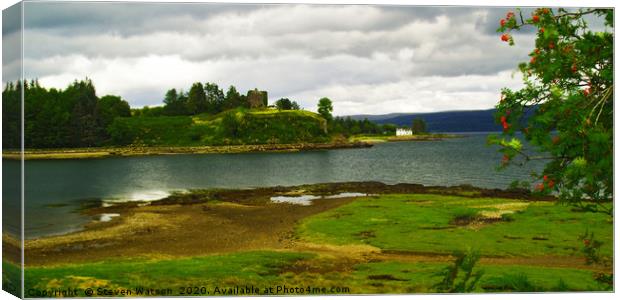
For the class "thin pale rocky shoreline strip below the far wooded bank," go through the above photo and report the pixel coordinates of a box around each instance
[2,141,373,160]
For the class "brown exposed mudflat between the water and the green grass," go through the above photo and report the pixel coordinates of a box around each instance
[3,182,595,269]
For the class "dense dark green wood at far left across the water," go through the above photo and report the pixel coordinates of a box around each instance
[2,79,131,149]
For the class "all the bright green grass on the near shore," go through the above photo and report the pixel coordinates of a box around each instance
[12,194,613,296]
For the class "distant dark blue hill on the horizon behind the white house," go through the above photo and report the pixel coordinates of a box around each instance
[350,109,502,132]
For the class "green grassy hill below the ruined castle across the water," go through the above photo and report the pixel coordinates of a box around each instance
[108,108,329,146]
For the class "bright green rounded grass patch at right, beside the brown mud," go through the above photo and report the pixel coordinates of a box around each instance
[298,195,613,256]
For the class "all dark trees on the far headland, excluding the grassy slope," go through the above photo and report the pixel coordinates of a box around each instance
[2,79,396,149]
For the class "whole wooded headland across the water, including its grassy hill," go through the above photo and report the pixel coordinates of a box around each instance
[2,79,396,149]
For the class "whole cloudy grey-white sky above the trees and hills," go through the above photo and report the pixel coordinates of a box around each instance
[3,2,534,115]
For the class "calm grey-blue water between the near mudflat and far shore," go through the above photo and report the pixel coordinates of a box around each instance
[3,134,542,238]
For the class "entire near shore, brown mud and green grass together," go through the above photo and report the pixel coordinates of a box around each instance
[3,181,613,293]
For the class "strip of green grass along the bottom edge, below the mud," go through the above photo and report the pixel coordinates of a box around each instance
[9,251,605,295]
